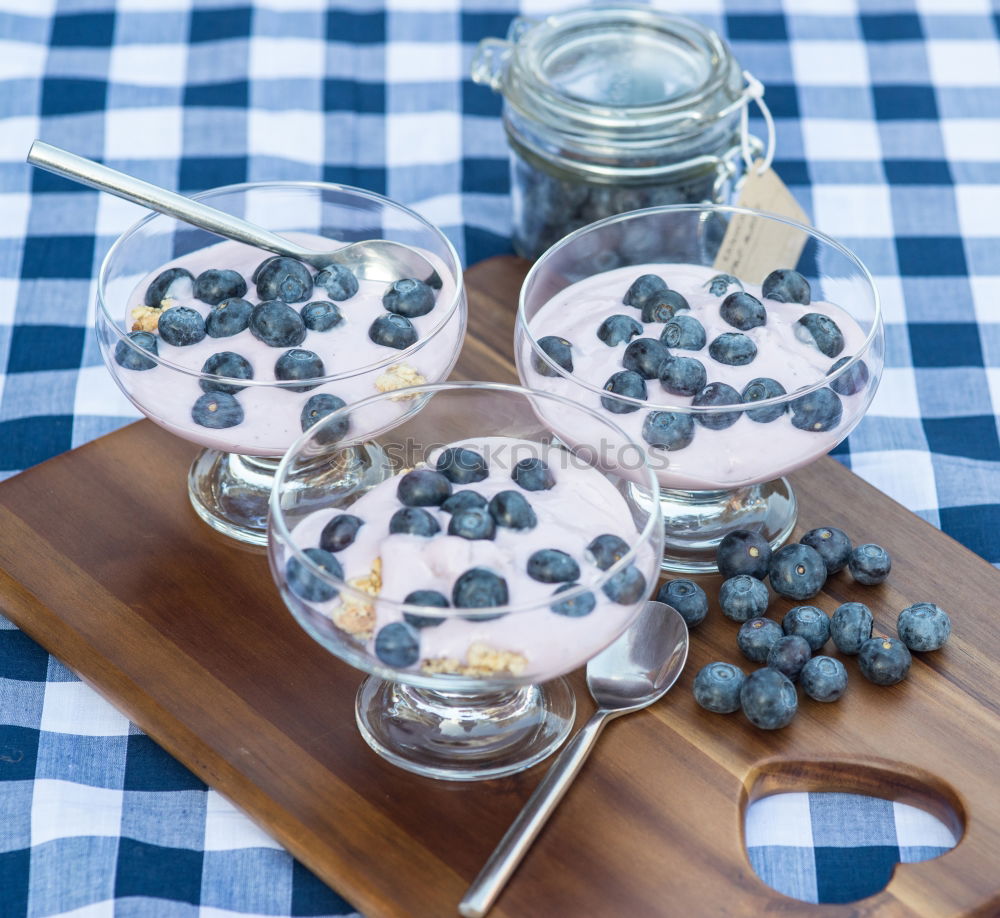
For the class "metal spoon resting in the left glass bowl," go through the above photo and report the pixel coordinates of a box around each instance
[27,140,441,287]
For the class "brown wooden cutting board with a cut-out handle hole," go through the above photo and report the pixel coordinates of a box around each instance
[0,257,1000,918]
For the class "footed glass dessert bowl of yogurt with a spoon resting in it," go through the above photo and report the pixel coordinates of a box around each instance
[96,182,466,545]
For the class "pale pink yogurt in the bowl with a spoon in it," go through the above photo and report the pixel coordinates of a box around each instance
[111,233,464,457]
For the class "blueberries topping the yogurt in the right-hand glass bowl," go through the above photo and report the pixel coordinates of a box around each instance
[534,269,869,450]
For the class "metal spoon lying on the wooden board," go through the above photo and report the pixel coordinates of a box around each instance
[458,602,688,918]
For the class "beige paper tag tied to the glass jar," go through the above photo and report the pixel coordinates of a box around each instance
[714,160,810,284]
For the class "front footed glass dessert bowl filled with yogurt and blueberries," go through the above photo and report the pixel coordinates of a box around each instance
[269,382,663,780]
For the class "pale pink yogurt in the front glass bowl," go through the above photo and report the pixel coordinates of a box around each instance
[282,437,656,680]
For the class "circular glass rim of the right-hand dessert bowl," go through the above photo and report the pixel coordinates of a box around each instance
[514,204,883,417]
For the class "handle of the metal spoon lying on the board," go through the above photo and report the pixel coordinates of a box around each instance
[458,708,615,918]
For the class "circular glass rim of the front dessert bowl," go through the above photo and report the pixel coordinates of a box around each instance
[267,380,663,621]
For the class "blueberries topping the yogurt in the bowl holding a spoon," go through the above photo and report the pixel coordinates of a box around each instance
[115,255,435,430]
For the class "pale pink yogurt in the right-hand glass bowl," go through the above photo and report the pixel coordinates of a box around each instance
[518,264,872,490]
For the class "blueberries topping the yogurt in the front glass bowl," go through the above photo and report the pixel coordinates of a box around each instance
[286,447,646,667]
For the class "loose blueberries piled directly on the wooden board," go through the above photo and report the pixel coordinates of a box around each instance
[657,527,951,730]
